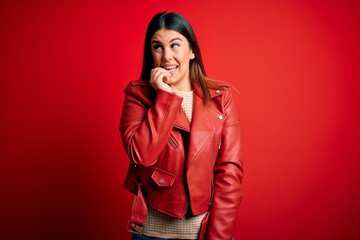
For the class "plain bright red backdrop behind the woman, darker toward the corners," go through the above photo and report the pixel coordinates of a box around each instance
[0,0,360,240]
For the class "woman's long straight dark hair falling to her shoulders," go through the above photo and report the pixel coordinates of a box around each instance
[140,12,210,103]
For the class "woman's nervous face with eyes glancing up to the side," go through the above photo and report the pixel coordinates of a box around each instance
[151,29,195,91]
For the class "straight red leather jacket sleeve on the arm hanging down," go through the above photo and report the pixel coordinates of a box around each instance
[206,89,243,240]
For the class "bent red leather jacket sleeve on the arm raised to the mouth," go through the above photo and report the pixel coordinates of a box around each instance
[120,83,182,167]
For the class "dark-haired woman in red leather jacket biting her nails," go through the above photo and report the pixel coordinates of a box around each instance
[120,12,243,240]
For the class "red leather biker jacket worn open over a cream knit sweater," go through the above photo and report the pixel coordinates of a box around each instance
[120,80,243,240]
